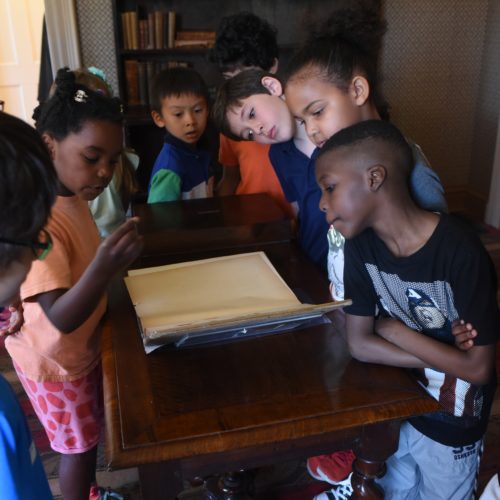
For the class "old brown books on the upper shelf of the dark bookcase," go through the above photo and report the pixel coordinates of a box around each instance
[121,10,215,50]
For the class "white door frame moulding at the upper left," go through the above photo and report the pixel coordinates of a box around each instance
[45,0,81,77]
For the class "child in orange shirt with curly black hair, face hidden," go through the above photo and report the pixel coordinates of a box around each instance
[212,12,295,217]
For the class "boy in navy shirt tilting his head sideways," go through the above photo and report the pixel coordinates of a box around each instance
[212,69,328,270]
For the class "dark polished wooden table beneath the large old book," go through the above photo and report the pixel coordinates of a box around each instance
[103,197,437,500]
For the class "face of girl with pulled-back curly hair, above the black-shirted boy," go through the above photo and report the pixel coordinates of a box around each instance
[285,68,363,147]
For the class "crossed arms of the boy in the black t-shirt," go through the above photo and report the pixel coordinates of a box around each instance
[346,314,495,384]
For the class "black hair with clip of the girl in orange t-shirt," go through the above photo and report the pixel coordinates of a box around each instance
[33,68,123,141]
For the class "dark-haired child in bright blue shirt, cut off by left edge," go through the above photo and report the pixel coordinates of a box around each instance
[0,112,56,500]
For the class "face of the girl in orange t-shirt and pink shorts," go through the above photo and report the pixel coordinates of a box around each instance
[44,120,123,201]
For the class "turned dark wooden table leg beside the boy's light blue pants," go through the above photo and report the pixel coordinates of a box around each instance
[351,421,401,500]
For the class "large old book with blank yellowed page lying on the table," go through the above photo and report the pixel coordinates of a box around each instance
[125,252,349,351]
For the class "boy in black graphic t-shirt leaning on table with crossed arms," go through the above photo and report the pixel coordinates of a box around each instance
[316,120,499,500]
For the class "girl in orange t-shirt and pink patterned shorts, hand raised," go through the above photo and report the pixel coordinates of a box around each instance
[6,68,142,500]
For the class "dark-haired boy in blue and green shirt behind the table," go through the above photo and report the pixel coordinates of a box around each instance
[148,67,214,203]
